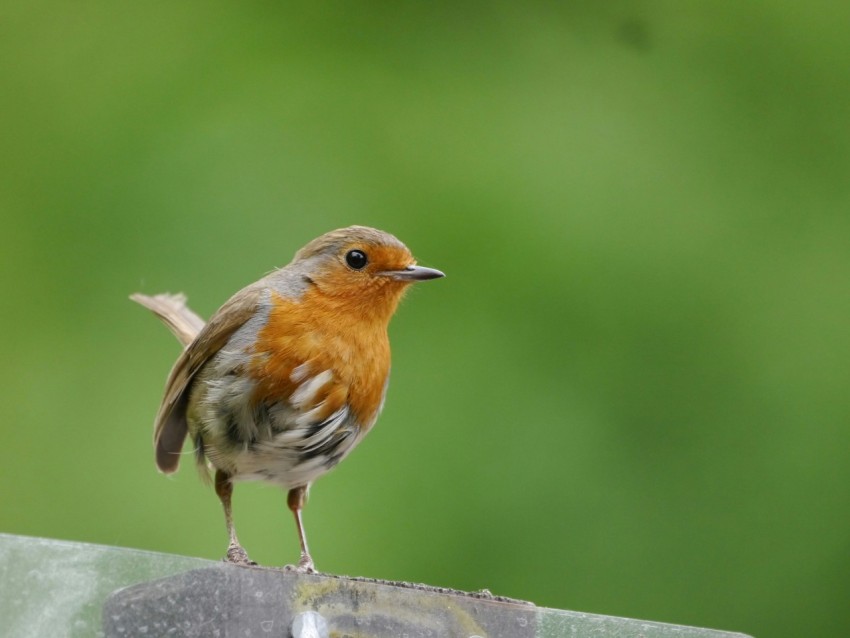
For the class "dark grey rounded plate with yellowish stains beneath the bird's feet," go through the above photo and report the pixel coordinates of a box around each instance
[103,564,538,638]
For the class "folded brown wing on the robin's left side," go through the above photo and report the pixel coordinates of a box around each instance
[149,282,263,474]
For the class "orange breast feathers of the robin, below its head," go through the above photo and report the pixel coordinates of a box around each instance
[251,290,390,427]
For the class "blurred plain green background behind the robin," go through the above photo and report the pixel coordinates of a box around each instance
[0,0,850,638]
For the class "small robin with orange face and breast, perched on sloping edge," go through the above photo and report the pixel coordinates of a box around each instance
[131,226,444,573]
